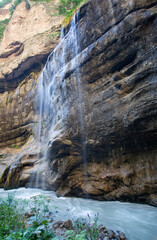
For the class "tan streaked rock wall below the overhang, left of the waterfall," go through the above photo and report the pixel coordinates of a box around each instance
[0,74,37,147]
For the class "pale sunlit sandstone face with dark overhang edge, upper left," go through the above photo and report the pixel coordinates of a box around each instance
[0,1,63,92]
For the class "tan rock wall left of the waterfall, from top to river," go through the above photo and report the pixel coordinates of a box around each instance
[0,0,63,188]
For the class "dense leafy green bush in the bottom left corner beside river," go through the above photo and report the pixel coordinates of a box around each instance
[0,195,54,240]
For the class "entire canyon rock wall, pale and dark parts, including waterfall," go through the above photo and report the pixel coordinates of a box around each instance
[0,0,157,205]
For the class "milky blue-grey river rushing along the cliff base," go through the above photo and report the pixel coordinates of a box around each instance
[0,188,157,240]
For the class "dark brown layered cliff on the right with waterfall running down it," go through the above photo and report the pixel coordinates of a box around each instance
[1,0,157,204]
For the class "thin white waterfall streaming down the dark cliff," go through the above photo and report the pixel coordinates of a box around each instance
[33,12,87,189]
